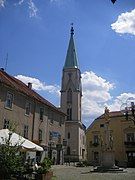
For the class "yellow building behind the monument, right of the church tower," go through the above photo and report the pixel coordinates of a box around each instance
[86,111,135,166]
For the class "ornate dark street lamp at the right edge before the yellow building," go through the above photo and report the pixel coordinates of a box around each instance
[120,97,135,125]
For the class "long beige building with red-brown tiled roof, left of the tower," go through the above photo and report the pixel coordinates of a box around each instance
[0,69,65,164]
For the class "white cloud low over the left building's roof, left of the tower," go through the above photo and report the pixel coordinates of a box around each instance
[15,75,60,96]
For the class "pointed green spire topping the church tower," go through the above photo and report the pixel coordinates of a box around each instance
[64,23,79,69]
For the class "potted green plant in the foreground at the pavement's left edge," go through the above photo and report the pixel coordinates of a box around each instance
[36,158,53,180]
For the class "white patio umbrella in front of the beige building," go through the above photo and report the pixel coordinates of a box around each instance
[0,129,43,151]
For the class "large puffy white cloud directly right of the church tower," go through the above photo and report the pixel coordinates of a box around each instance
[82,71,114,123]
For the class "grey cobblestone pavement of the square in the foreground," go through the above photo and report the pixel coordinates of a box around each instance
[52,165,135,180]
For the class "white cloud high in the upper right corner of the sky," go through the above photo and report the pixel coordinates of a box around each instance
[111,9,135,35]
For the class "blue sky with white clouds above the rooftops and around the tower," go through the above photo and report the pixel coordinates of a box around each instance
[0,0,135,127]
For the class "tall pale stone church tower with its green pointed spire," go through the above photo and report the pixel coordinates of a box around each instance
[61,26,86,162]
